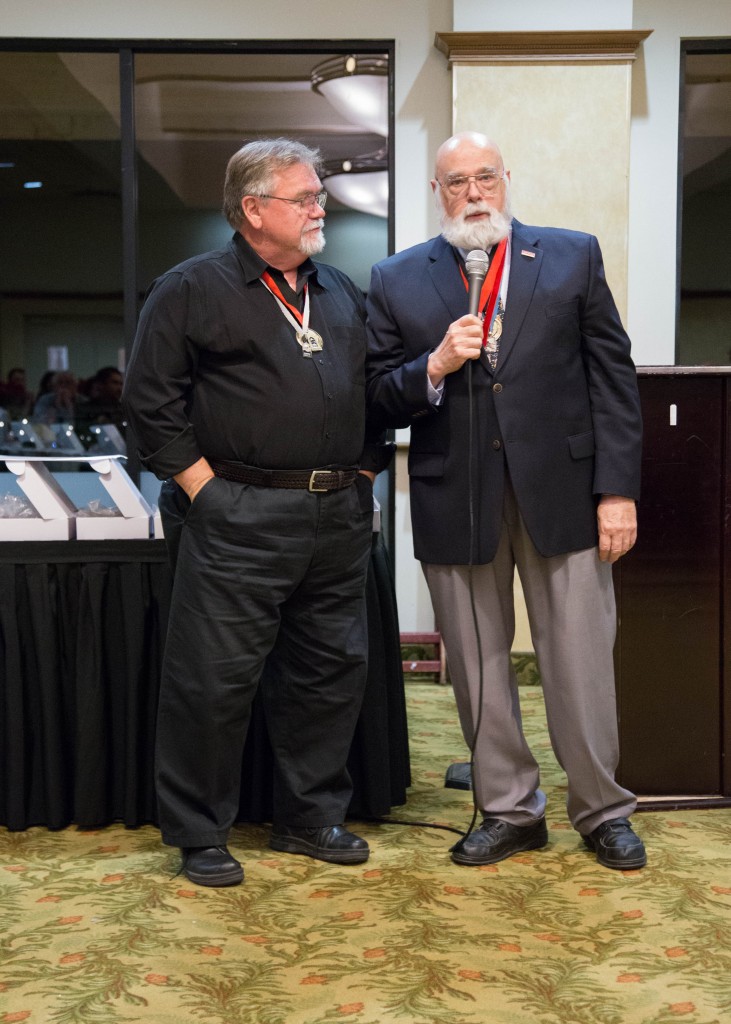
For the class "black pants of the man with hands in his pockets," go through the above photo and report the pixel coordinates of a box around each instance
[156,476,373,847]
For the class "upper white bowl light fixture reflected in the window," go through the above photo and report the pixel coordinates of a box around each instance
[310,54,388,137]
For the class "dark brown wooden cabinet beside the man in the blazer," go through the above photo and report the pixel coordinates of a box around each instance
[614,368,731,806]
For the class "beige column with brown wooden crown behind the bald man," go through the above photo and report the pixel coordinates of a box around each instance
[435,31,650,651]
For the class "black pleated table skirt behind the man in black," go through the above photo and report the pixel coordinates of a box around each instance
[0,535,411,829]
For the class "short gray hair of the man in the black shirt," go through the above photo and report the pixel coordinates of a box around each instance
[223,138,321,229]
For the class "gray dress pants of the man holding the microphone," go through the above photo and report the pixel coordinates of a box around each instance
[423,479,637,835]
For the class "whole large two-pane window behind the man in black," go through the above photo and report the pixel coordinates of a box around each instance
[0,40,393,552]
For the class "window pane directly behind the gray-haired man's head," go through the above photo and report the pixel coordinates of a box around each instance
[134,52,388,291]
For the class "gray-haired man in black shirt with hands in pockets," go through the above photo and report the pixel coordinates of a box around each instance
[124,139,381,886]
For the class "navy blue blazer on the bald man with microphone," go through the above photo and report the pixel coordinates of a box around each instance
[366,221,642,564]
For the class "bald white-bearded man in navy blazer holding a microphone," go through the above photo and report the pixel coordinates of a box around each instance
[367,132,646,869]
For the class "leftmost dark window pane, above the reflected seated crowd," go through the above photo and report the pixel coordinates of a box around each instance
[0,52,124,403]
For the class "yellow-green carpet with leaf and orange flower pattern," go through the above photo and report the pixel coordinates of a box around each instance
[0,682,731,1024]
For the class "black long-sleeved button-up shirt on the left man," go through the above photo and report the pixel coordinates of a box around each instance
[124,232,373,478]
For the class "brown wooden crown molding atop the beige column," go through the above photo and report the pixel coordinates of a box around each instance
[434,29,652,66]
